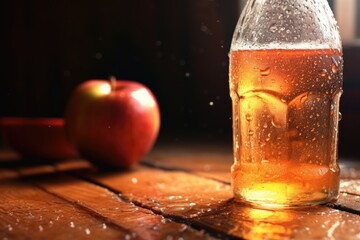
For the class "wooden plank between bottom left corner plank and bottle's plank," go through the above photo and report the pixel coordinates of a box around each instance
[36,175,217,239]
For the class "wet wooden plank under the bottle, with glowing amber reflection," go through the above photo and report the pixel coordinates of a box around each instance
[83,168,360,239]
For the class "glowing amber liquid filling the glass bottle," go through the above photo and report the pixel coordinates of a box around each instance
[230,49,342,207]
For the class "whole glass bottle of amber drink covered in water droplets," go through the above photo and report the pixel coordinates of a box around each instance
[229,0,343,208]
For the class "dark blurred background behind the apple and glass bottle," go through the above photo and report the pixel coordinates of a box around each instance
[0,0,360,159]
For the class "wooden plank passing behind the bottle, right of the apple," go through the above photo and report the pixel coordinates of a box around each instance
[145,146,360,213]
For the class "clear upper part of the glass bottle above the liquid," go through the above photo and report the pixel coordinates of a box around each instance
[231,0,341,50]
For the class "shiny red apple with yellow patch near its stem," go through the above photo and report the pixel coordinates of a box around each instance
[65,79,160,167]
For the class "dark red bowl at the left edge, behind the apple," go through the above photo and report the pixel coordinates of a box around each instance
[0,117,77,159]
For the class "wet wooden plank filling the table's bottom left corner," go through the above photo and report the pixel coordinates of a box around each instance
[0,181,129,239]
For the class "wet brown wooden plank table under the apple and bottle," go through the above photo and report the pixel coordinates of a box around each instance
[0,142,360,240]
